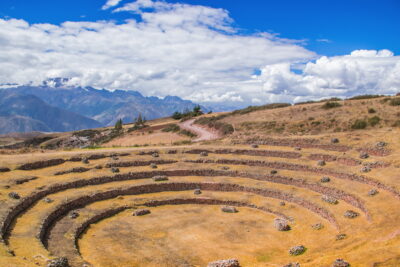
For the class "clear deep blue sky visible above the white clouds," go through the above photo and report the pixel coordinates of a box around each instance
[0,0,400,56]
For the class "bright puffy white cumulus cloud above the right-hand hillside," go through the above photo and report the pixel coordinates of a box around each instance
[255,50,400,101]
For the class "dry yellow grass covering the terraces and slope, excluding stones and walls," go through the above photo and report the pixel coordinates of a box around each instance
[0,100,400,267]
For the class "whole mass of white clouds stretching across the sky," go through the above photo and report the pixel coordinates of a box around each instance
[0,0,400,105]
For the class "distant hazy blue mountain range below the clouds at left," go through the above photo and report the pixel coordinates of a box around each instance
[0,78,205,134]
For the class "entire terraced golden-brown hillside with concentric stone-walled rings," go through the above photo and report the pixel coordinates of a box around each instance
[0,96,400,267]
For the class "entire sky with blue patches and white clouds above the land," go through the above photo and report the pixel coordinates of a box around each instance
[0,0,400,107]
